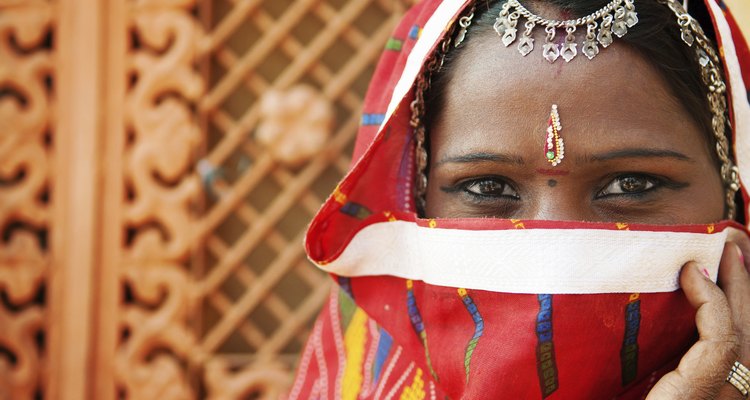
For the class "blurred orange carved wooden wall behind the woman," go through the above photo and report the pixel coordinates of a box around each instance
[0,0,750,400]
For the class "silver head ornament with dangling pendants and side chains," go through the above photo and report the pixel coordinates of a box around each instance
[410,0,740,219]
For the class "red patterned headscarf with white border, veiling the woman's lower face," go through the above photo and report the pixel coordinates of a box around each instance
[289,0,750,399]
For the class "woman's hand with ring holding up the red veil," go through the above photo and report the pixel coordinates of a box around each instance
[647,233,750,400]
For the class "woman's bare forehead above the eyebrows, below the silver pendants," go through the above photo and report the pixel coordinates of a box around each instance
[428,29,709,159]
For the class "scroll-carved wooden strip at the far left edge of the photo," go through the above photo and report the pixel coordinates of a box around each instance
[0,1,53,399]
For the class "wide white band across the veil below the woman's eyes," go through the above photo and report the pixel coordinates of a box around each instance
[318,221,734,294]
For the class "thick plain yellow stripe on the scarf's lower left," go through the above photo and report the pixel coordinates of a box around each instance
[342,307,367,400]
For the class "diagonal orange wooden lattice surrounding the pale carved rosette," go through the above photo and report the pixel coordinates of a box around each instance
[194,0,407,398]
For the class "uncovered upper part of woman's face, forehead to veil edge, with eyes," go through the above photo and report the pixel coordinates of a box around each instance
[426,32,724,224]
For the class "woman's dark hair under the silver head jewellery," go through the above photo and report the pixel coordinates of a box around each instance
[424,0,719,161]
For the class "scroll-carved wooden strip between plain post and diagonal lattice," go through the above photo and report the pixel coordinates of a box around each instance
[115,0,203,400]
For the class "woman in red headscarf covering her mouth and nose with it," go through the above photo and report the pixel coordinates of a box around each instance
[290,0,750,399]
